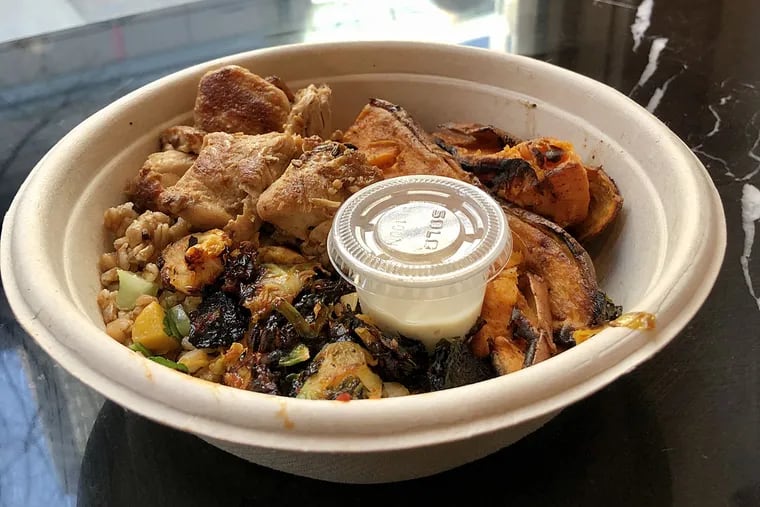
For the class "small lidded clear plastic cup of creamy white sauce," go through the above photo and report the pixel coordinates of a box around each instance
[327,175,512,349]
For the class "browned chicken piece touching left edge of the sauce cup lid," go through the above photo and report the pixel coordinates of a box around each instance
[256,141,383,240]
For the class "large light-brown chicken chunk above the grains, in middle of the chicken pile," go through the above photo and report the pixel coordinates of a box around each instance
[159,132,301,229]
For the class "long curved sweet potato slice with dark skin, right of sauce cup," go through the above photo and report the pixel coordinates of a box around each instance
[505,207,605,336]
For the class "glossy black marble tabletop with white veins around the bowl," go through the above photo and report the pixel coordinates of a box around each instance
[0,0,760,507]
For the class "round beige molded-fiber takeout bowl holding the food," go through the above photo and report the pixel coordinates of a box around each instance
[1,42,726,483]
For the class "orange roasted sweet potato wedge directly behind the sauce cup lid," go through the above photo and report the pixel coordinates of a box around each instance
[343,99,476,183]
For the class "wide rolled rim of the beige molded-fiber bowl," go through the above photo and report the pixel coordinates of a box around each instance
[0,41,726,453]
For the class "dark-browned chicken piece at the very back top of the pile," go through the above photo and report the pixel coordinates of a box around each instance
[194,65,290,134]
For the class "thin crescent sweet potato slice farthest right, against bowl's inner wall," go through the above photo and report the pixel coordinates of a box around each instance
[571,167,623,241]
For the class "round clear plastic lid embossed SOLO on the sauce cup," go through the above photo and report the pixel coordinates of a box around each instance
[327,175,512,293]
